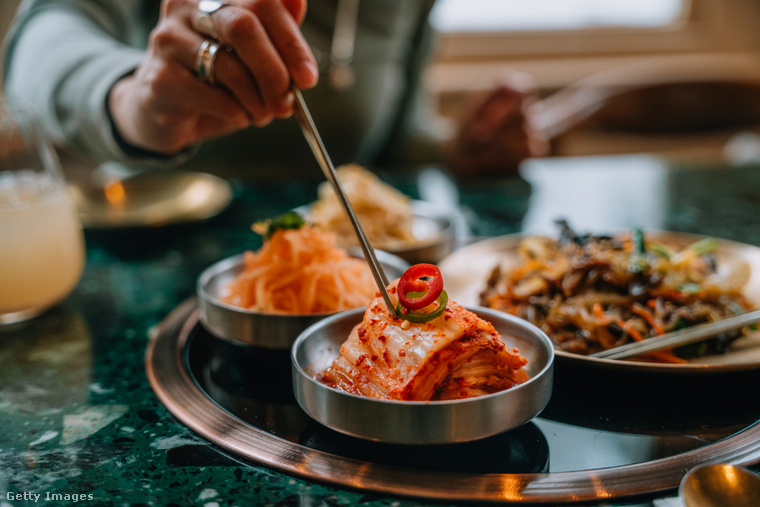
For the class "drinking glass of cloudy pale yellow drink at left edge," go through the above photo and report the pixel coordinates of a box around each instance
[0,101,85,325]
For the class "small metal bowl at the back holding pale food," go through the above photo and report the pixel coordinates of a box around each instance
[295,200,457,264]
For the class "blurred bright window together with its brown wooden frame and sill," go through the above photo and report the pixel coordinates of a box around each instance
[428,0,760,93]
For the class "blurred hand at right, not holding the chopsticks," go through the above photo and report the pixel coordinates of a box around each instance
[446,72,549,176]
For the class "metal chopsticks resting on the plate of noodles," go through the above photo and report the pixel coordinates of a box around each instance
[588,310,760,359]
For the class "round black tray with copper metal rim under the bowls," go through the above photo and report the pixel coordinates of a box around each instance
[146,300,760,504]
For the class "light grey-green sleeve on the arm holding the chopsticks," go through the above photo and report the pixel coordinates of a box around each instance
[2,0,193,163]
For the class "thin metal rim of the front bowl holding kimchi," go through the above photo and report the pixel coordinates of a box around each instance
[290,306,555,407]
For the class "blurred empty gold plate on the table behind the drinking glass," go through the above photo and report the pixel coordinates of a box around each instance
[70,170,232,229]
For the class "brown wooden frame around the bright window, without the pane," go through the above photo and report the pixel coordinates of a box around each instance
[425,0,760,96]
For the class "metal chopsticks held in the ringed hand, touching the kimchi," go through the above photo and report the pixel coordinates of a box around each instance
[293,87,396,315]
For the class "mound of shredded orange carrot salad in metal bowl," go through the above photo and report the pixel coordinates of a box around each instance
[223,225,377,314]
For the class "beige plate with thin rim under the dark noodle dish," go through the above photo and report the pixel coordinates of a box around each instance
[439,231,760,374]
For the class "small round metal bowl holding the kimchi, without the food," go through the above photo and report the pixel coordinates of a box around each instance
[291,307,554,444]
